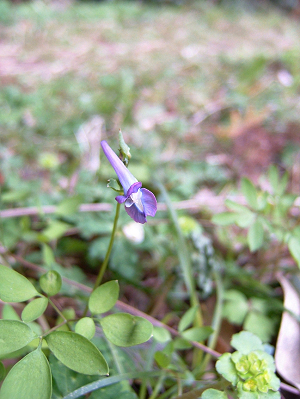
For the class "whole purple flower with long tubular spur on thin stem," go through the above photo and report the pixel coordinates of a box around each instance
[101,141,157,224]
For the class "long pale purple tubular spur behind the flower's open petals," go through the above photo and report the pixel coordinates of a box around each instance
[101,140,137,195]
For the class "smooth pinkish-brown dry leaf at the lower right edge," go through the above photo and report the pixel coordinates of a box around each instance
[275,275,300,389]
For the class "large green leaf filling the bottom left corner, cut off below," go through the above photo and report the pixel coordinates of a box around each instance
[0,349,52,399]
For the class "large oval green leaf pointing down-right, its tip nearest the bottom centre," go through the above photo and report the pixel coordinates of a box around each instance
[45,331,108,375]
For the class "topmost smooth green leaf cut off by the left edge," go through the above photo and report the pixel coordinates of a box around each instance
[0,265,38,302]
